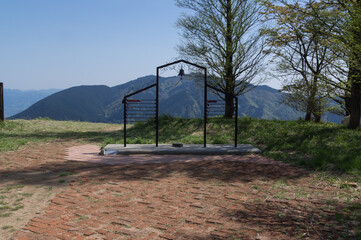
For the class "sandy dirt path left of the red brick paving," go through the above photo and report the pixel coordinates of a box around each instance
[0,141,85,240]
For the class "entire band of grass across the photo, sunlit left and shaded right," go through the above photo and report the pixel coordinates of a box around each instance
[0,116,361,176]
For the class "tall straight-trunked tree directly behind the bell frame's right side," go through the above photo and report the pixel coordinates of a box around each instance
[176,0,265,118]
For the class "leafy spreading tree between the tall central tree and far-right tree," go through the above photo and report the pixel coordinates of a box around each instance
[263,0,334,122]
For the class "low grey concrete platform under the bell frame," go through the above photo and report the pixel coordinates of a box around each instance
[102,144,261,155]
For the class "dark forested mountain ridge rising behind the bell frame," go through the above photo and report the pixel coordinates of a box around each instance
[10,76,341,123]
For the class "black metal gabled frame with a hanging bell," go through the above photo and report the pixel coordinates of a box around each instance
[122,60,238,147]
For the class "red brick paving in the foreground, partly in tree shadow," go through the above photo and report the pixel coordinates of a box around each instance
[4,143,358,240]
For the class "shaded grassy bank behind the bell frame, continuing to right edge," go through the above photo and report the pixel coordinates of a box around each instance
[103,116,361,176]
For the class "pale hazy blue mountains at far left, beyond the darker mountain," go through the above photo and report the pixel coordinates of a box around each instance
[4,88,60,118]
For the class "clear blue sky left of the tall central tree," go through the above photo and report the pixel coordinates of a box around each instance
[0,0,276,90]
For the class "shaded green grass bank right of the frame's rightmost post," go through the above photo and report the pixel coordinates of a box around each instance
[236,118,361,175]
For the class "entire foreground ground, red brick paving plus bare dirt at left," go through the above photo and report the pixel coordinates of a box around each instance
[0,141,361,240]
